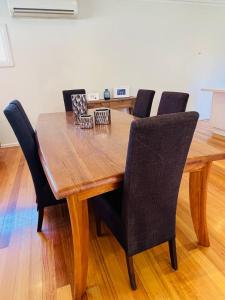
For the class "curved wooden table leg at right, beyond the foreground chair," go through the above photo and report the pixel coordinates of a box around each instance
[189,163,211,247]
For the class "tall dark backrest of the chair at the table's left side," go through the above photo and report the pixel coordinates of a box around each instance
[4,100,47,196]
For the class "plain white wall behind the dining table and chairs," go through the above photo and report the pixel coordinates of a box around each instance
[0,0,225,144]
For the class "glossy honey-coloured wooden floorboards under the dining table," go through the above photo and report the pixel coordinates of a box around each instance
[0,126,225,300]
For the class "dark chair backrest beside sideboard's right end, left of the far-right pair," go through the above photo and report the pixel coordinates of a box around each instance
[133,90,155,118]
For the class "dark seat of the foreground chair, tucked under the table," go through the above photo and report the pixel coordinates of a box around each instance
[92,189,124,247]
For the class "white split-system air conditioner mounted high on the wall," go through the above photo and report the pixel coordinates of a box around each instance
[8,0,78,18]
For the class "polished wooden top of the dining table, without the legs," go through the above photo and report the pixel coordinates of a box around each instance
[36,110,225,199]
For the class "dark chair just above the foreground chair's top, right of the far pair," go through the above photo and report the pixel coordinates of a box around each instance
[157,92,189,115]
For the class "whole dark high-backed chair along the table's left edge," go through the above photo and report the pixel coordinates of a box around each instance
[4,100,65,232]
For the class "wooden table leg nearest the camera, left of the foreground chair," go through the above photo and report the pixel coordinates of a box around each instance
[67,195,89,300]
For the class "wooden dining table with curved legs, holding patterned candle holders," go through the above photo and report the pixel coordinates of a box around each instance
[36,110,225,299]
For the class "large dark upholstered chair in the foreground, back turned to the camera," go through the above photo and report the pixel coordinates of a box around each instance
[93,112,199,289]
